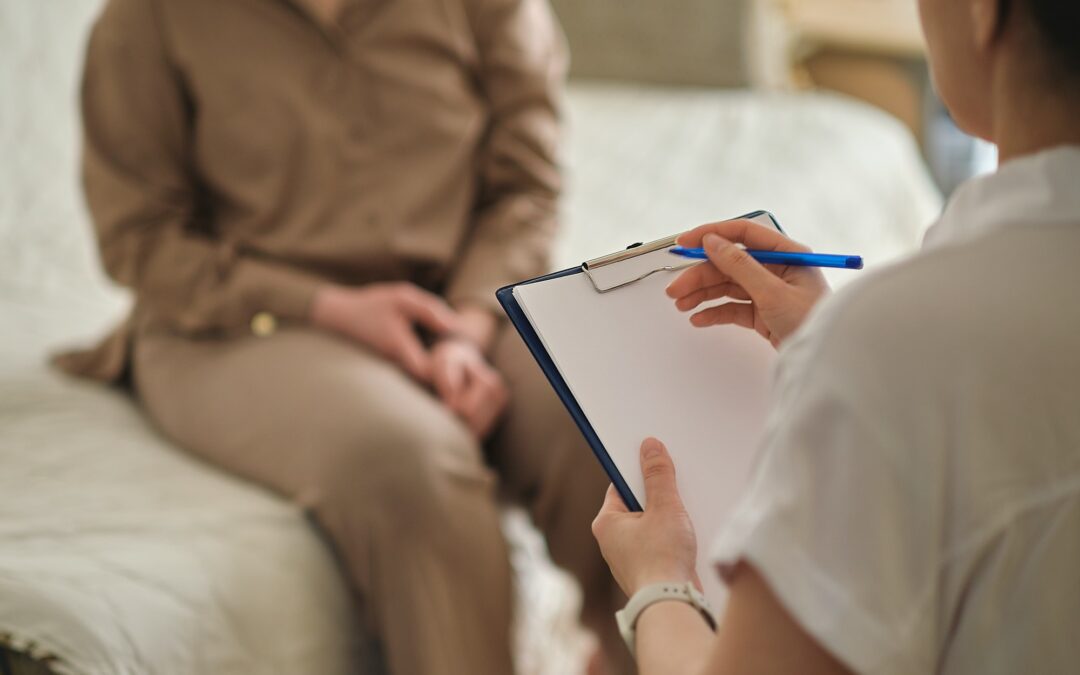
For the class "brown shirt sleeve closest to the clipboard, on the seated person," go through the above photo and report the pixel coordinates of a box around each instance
[446,0,567,309]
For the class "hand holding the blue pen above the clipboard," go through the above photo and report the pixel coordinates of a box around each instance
[667,220,833,347]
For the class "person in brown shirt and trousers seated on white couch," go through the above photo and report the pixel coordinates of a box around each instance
[59,0,629,675]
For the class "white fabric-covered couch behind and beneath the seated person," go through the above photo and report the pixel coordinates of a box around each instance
[0,0,940,675]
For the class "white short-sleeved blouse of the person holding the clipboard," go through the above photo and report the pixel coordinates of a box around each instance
[712,147,1080,674]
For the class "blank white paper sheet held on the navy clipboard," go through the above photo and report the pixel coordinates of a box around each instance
[514,251,774,606]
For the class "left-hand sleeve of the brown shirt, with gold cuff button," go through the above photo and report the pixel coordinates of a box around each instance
[82,0,318,334]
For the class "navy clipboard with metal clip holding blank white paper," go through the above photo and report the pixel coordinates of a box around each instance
[496,211,783,602]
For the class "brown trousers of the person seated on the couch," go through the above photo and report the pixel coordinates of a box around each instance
[134,328,626,675]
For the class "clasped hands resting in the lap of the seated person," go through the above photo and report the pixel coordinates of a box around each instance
[311,282,509,438]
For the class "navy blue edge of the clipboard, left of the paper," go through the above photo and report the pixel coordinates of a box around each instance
[495,211,784,511]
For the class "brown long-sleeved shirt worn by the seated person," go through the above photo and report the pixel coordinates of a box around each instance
[60,0,566,379]
